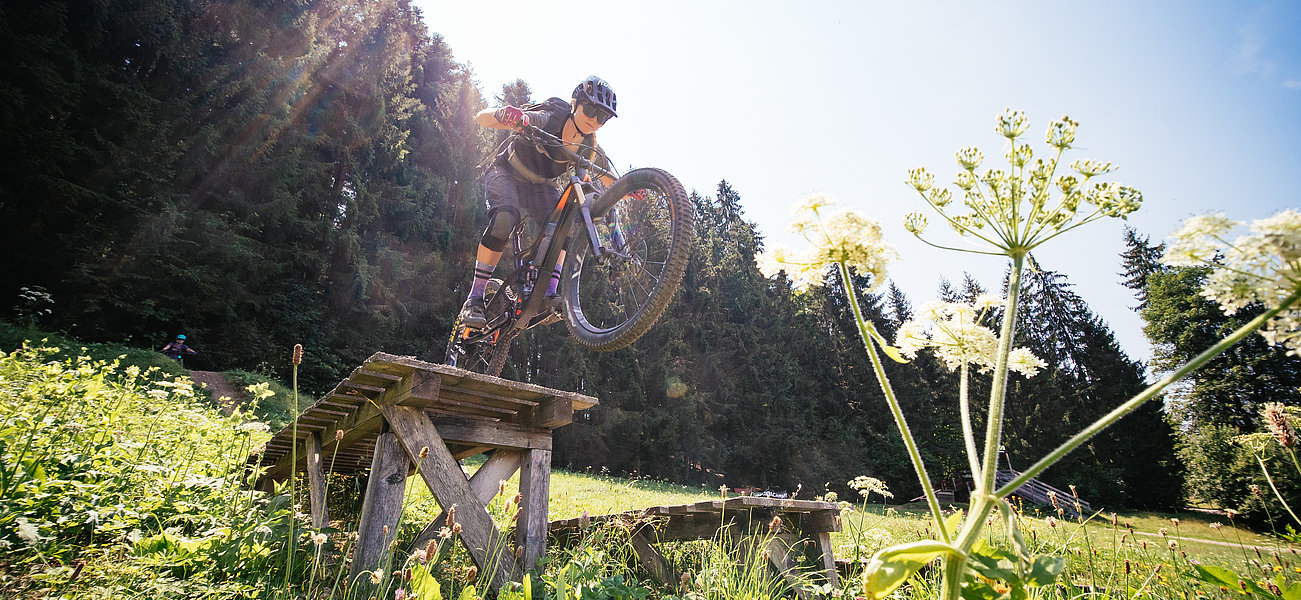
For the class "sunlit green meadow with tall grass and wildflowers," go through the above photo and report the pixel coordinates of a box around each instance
[0,340,1301,600]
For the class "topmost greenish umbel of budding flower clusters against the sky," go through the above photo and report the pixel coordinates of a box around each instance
[904,111,1142,255]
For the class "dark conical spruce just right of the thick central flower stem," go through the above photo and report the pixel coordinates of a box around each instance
[1006,259,1181,506]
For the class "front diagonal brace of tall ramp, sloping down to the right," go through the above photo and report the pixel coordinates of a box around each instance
[381,405,520,590]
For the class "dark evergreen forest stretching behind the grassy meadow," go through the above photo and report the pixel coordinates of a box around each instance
[0,0,1301,511]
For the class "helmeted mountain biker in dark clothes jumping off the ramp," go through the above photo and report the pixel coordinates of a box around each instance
[462,75,618,328]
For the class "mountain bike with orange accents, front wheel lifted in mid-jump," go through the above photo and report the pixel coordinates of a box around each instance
[445,125,695,376]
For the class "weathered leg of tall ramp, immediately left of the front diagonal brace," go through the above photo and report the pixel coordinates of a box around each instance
[347,432,409,587]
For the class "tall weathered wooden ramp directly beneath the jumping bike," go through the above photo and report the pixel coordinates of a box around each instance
[248,353,597,590]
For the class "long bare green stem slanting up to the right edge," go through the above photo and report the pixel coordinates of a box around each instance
[995,288,1301,496]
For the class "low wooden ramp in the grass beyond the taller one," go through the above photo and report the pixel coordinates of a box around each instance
[550,496,840,596]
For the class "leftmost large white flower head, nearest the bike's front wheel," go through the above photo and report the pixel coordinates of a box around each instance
[758,195,898,288]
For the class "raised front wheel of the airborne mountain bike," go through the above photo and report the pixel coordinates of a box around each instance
[561,169,695,351]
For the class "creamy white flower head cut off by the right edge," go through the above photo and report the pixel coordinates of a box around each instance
[1162,208,1301,355]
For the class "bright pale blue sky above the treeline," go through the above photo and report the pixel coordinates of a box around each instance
[415,0,1301,358]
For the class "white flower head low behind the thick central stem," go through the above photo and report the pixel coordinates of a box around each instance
[895,295,1046,377]
